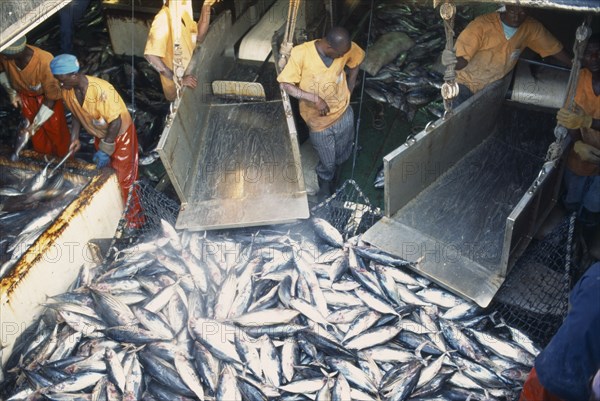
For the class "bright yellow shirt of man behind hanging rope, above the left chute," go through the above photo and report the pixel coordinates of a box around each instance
[144,0,198,101]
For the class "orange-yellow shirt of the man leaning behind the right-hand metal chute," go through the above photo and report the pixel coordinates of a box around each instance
[456,13,562,93]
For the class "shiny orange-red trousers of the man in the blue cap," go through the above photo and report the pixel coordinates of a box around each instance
[95,124,145,228]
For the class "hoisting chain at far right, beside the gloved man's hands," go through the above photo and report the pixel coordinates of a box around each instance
[546,15,592,162]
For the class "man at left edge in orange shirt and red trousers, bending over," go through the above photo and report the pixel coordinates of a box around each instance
[0,36,70,158]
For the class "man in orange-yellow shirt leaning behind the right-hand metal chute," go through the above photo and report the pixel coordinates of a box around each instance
[442,5,571,106]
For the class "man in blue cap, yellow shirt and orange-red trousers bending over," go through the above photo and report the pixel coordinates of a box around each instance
[50,54,144,229]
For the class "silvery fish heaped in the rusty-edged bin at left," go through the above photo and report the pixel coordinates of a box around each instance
[0,162,82,279]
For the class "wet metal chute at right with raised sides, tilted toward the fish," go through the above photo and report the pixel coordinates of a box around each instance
[363,78,555,307]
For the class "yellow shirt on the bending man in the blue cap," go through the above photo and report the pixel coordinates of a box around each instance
[62,75,132,139]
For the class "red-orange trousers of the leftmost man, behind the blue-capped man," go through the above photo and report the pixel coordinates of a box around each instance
[19,92,71,157]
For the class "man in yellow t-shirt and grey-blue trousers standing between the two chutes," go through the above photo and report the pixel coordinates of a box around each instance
[277,27,365,200]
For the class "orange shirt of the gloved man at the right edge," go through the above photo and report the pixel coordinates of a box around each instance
[567,68,600,176]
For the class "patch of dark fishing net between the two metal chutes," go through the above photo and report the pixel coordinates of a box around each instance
[311,180,382,239]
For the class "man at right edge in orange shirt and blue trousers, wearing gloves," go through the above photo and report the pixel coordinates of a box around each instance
[557,33,600,259]
